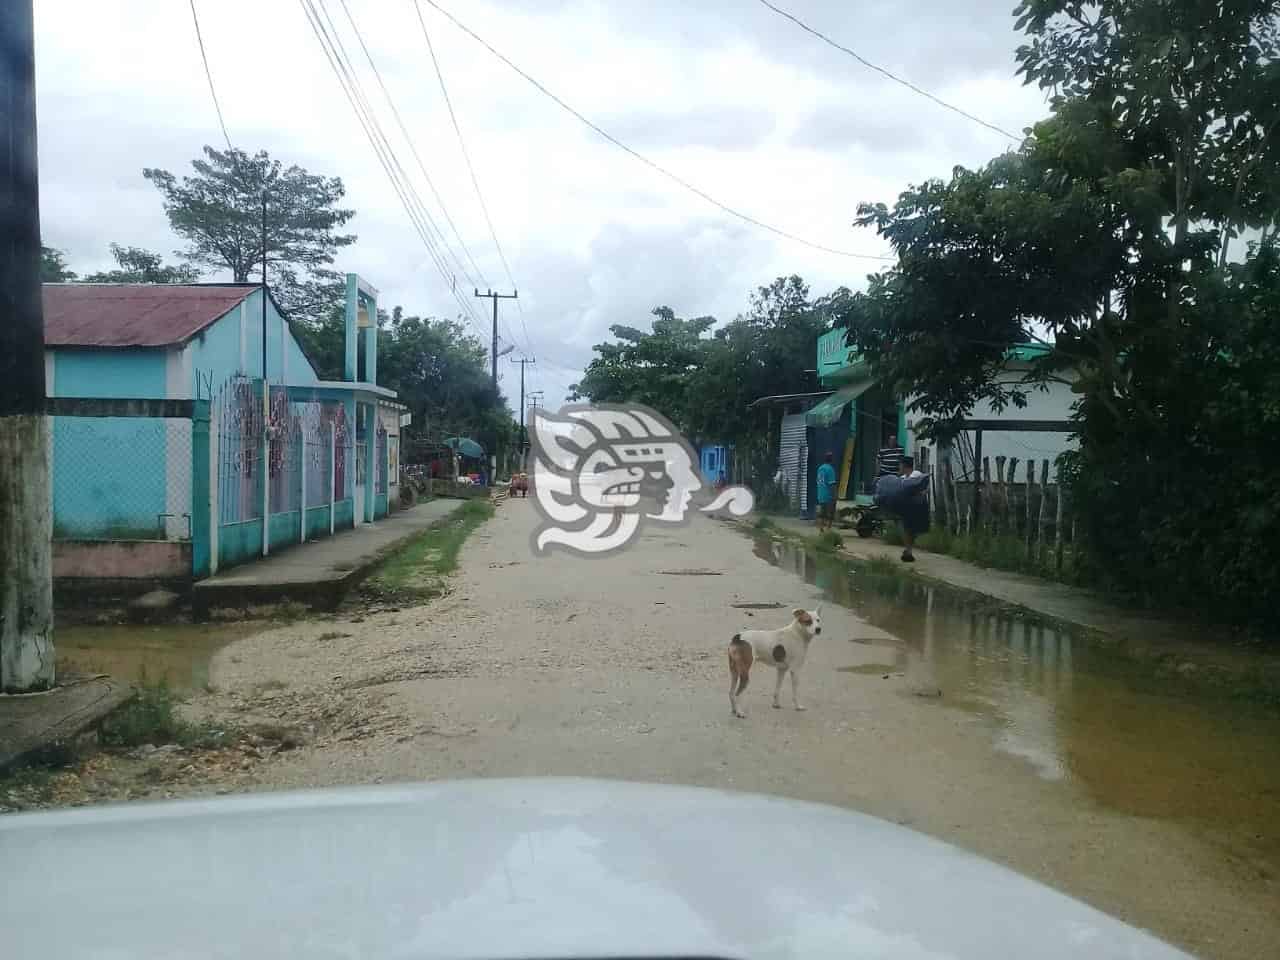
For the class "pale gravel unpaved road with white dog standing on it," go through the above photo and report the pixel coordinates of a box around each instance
[172,500,1280,957]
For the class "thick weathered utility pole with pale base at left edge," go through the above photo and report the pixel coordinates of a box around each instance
[0,0,54,694]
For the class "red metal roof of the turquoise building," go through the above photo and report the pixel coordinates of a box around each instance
[44,283,259,347]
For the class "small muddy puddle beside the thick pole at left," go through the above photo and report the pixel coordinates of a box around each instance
[54,623,262,690]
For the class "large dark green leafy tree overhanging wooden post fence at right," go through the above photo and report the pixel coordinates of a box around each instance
[840,0,1280,632]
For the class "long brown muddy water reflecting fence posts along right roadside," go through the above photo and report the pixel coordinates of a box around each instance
[755,540,1280,877]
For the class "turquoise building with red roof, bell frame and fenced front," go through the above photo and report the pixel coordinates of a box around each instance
[44,274,407,579]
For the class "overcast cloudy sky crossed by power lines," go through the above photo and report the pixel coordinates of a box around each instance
[36,0,1044,404]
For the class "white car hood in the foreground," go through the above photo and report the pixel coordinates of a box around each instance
[0,778,1185,960]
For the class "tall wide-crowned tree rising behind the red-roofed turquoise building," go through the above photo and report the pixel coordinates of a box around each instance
[142,146,356,323]
